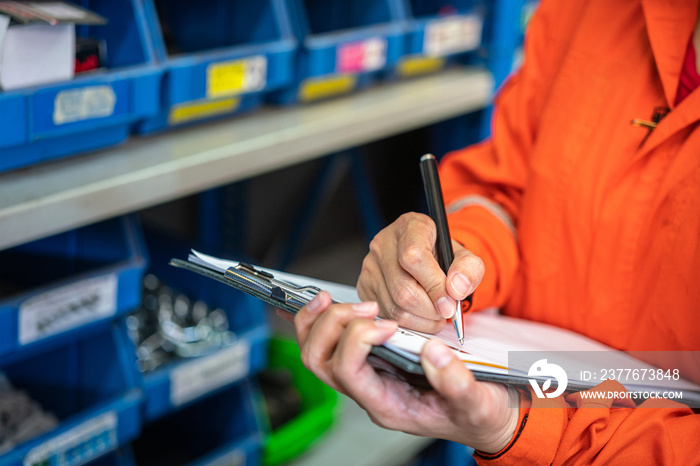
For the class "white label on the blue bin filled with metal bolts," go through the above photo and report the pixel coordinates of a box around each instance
[170,340,250,406]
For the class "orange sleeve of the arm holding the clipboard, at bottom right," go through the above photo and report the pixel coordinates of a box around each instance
[474,381,700,466]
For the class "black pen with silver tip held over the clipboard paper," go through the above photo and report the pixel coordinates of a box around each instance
[420,154,464,345]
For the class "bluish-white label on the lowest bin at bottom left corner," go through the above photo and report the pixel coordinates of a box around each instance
[24,411,118,466]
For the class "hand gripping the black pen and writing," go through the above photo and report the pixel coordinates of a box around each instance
[357,213,484,333]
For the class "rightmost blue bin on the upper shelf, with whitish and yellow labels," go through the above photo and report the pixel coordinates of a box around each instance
[397,0,487,77]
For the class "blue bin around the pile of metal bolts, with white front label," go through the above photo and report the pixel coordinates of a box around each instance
[132,235,269,421]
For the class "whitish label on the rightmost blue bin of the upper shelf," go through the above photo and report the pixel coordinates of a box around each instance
[423,15,483,57]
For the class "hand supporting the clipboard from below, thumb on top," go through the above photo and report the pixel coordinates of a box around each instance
[280,292,520,453]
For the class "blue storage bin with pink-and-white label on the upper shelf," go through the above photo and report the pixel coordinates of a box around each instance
[273,0,407,104]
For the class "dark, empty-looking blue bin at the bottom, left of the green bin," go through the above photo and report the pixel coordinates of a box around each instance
[133,381,262,466]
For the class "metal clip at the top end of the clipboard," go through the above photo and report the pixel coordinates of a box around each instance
[224,262,321,310]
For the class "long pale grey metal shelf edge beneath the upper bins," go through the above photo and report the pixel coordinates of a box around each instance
[0,68,493,249]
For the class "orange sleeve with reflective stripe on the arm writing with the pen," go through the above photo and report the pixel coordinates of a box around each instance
[440,1,582,309]
